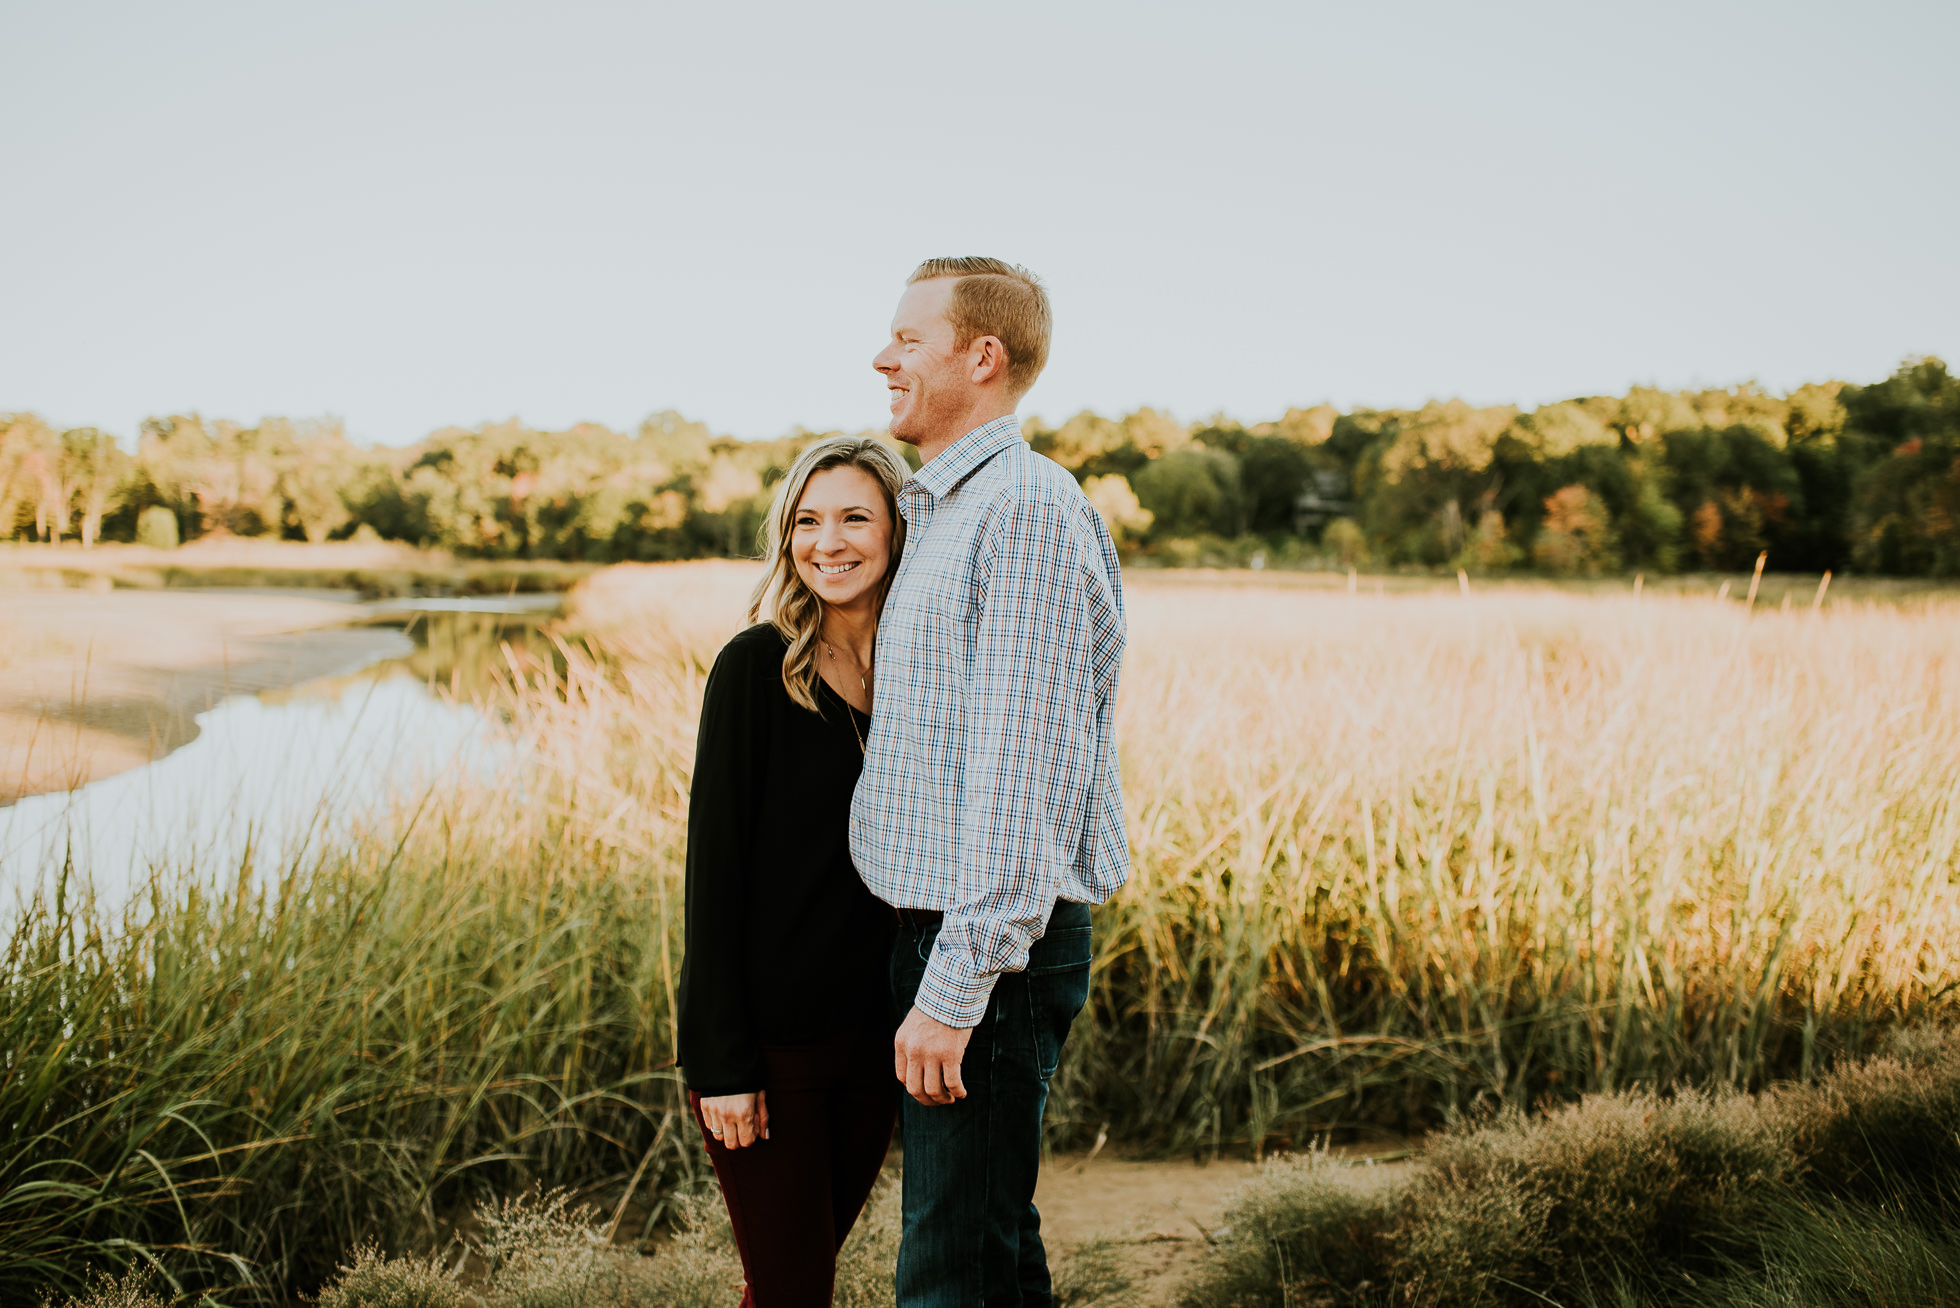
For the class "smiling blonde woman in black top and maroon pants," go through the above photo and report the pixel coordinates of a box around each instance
[680,437,906,1308]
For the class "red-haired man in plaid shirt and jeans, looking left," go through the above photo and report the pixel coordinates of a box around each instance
[851,259,1129,1308]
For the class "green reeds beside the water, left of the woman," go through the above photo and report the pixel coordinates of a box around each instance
[0,792,700,1302]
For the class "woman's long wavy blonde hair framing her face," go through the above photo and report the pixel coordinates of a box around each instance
[749,435,911,714]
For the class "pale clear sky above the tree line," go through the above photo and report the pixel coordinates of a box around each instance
[0,0,1960,443]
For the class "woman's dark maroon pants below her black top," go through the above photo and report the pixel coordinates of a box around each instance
[688,1035,898,1308]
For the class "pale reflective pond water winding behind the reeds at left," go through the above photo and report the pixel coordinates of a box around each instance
[0,596,557,916]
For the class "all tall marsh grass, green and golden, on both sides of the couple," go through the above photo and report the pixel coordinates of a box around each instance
[0,565,1960,1302]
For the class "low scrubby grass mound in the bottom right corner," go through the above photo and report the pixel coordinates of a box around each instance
[1180,1031,1960,1308]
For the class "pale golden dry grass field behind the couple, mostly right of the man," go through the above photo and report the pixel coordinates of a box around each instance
[541,565,1960,1147]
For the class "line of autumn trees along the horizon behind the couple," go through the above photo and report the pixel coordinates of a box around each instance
[0,359,1960,577]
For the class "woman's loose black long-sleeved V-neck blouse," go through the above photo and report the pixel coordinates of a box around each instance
[678,626,892,1094]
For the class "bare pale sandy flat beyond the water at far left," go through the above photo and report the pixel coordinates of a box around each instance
[0,588,403,804]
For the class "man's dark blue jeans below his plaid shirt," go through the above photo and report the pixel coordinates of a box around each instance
[892,900,1090,1308]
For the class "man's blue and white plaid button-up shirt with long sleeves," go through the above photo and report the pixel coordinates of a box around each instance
[851,416,1129,1026]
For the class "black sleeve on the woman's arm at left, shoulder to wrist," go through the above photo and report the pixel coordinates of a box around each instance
[676,641,766,1094]
